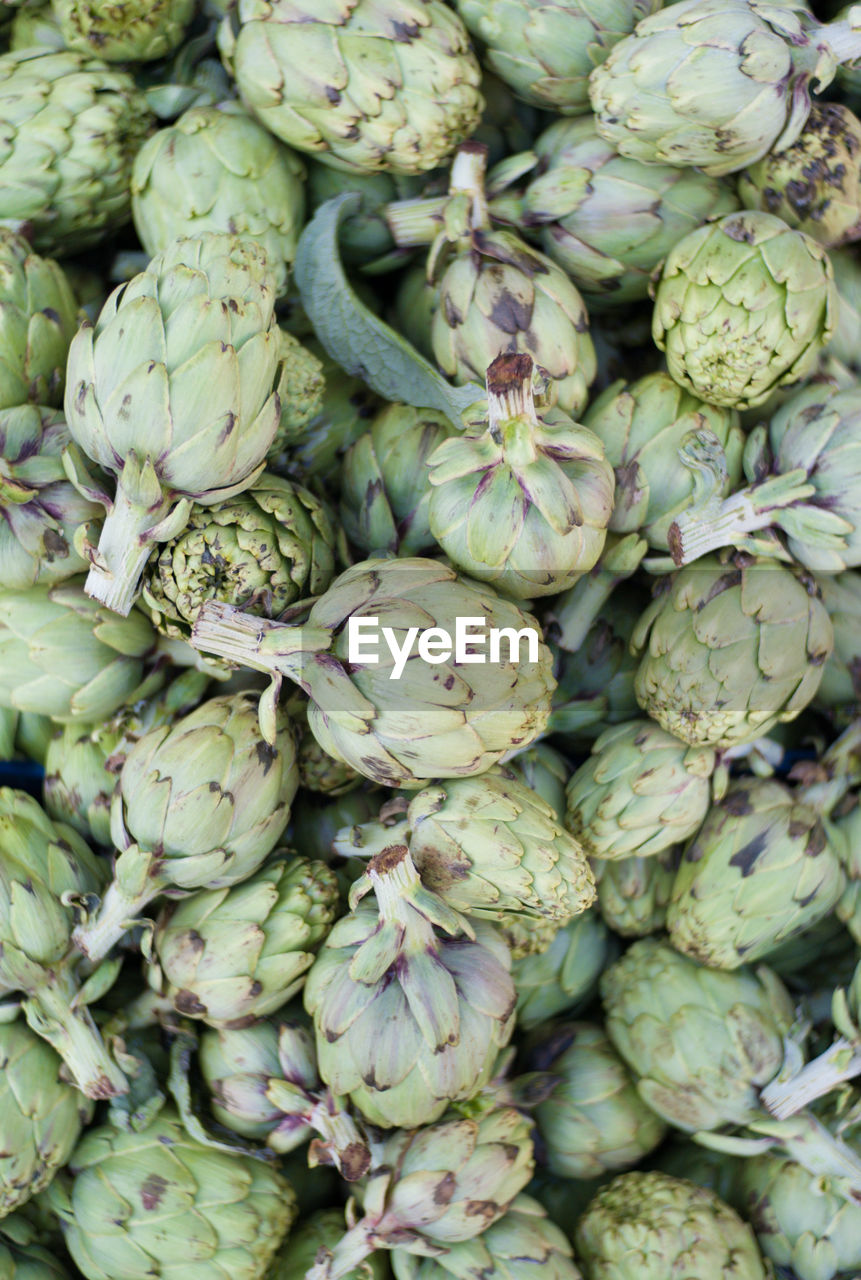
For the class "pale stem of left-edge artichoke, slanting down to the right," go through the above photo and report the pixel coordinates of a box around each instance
[23,970,128,1098]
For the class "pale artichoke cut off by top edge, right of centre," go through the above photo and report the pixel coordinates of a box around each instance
[455,0,661,115]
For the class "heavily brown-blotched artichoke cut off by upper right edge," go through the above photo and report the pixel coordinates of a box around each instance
[738,102,861,248]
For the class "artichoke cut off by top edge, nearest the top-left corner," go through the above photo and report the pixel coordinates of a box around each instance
[51,0,196,63]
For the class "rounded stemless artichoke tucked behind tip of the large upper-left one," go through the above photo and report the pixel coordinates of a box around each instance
[132,101,304,294]
